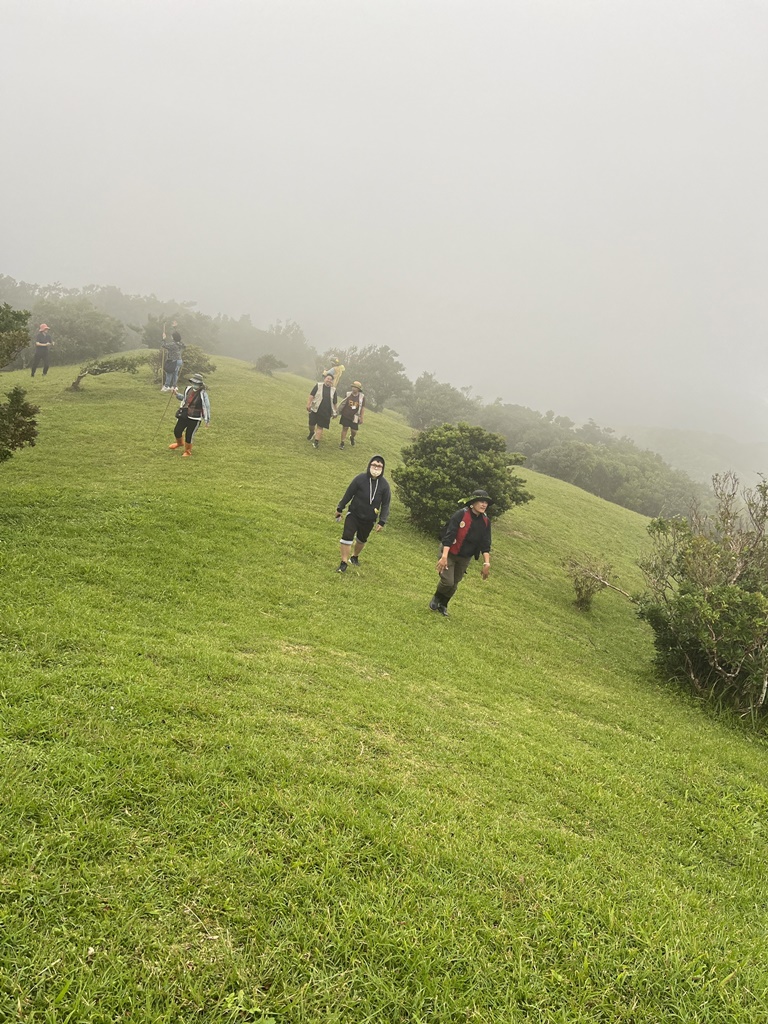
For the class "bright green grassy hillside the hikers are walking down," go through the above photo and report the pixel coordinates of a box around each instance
[0,359,768,1024]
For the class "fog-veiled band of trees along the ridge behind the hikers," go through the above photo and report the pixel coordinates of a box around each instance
[0,274,709,516]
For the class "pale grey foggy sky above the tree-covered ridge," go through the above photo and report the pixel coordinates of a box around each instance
[0,0,768,439]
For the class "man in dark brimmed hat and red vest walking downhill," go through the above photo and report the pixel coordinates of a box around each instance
[429,490,493,616]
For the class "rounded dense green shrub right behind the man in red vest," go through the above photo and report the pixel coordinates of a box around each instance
[392,423,532,536]
